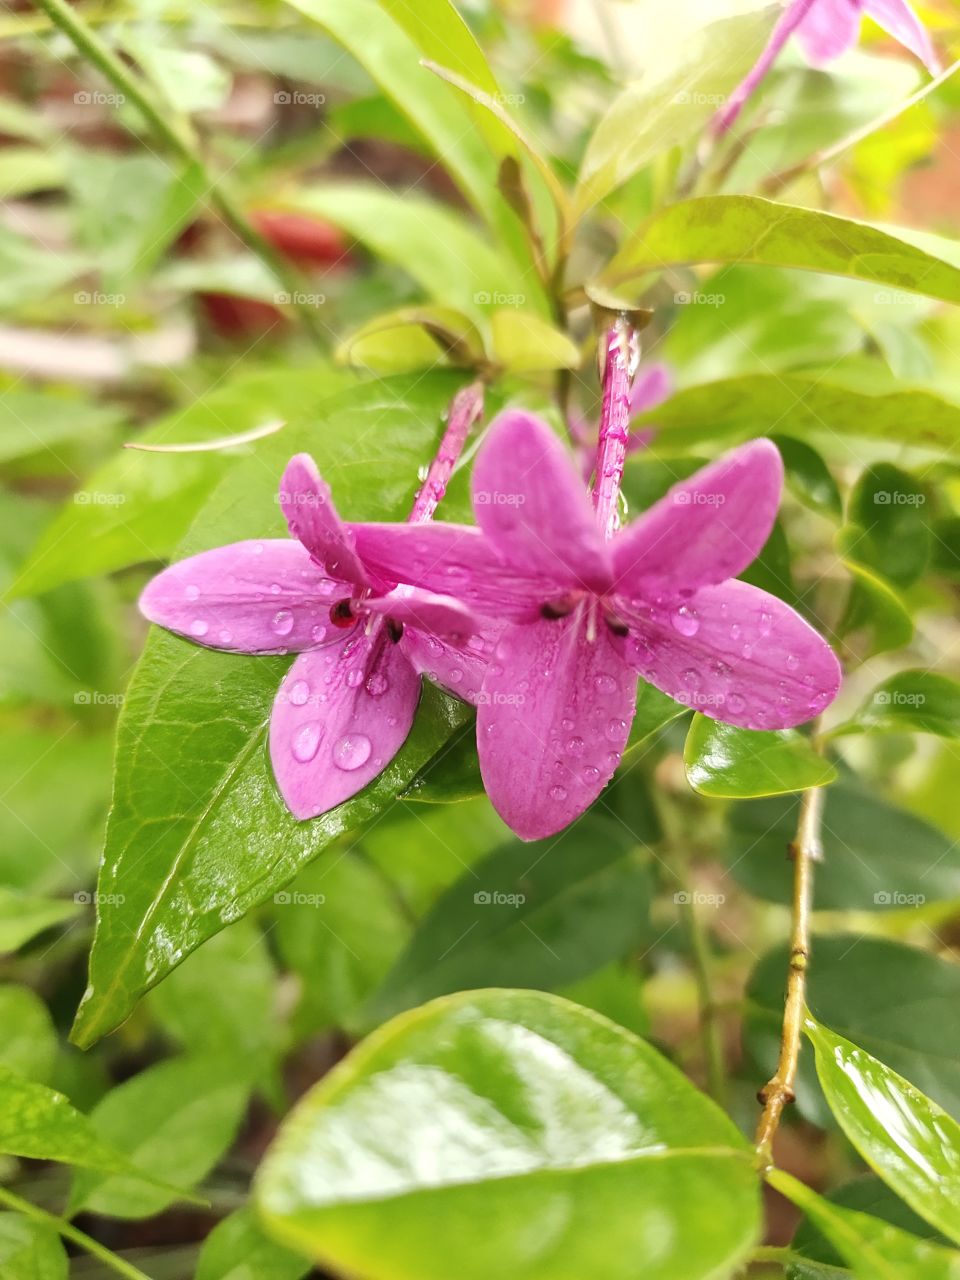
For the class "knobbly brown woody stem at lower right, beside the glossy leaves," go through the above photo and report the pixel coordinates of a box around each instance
[756,787,826,1166]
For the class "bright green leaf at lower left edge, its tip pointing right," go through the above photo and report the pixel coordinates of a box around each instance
[0,1066,148,1176]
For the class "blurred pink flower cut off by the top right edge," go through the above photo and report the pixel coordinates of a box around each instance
[713,0,941,134]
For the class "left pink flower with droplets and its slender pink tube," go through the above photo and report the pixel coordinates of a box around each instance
[140,388,492,819]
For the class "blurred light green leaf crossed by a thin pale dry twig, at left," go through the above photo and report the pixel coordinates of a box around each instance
[12,366,346,595]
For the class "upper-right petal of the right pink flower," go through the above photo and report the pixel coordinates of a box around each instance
[613,440,783,599]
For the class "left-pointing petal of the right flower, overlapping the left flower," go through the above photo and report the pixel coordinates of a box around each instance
[351,524,547,621]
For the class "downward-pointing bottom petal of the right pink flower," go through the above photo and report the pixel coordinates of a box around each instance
[476,608,636,840]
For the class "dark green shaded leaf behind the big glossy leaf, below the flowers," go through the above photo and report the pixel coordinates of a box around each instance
[367,814,652,1023]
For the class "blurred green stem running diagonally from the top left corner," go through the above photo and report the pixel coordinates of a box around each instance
[36,0,323,344]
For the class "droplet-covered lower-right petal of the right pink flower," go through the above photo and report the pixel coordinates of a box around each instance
[621,581,841,728]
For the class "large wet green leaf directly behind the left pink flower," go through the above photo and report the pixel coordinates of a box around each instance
[74,376,481,1046]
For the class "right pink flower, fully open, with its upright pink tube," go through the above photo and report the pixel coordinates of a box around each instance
[353,344,840,840]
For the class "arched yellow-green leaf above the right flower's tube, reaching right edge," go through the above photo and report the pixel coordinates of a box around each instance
[602,196,960,302]
